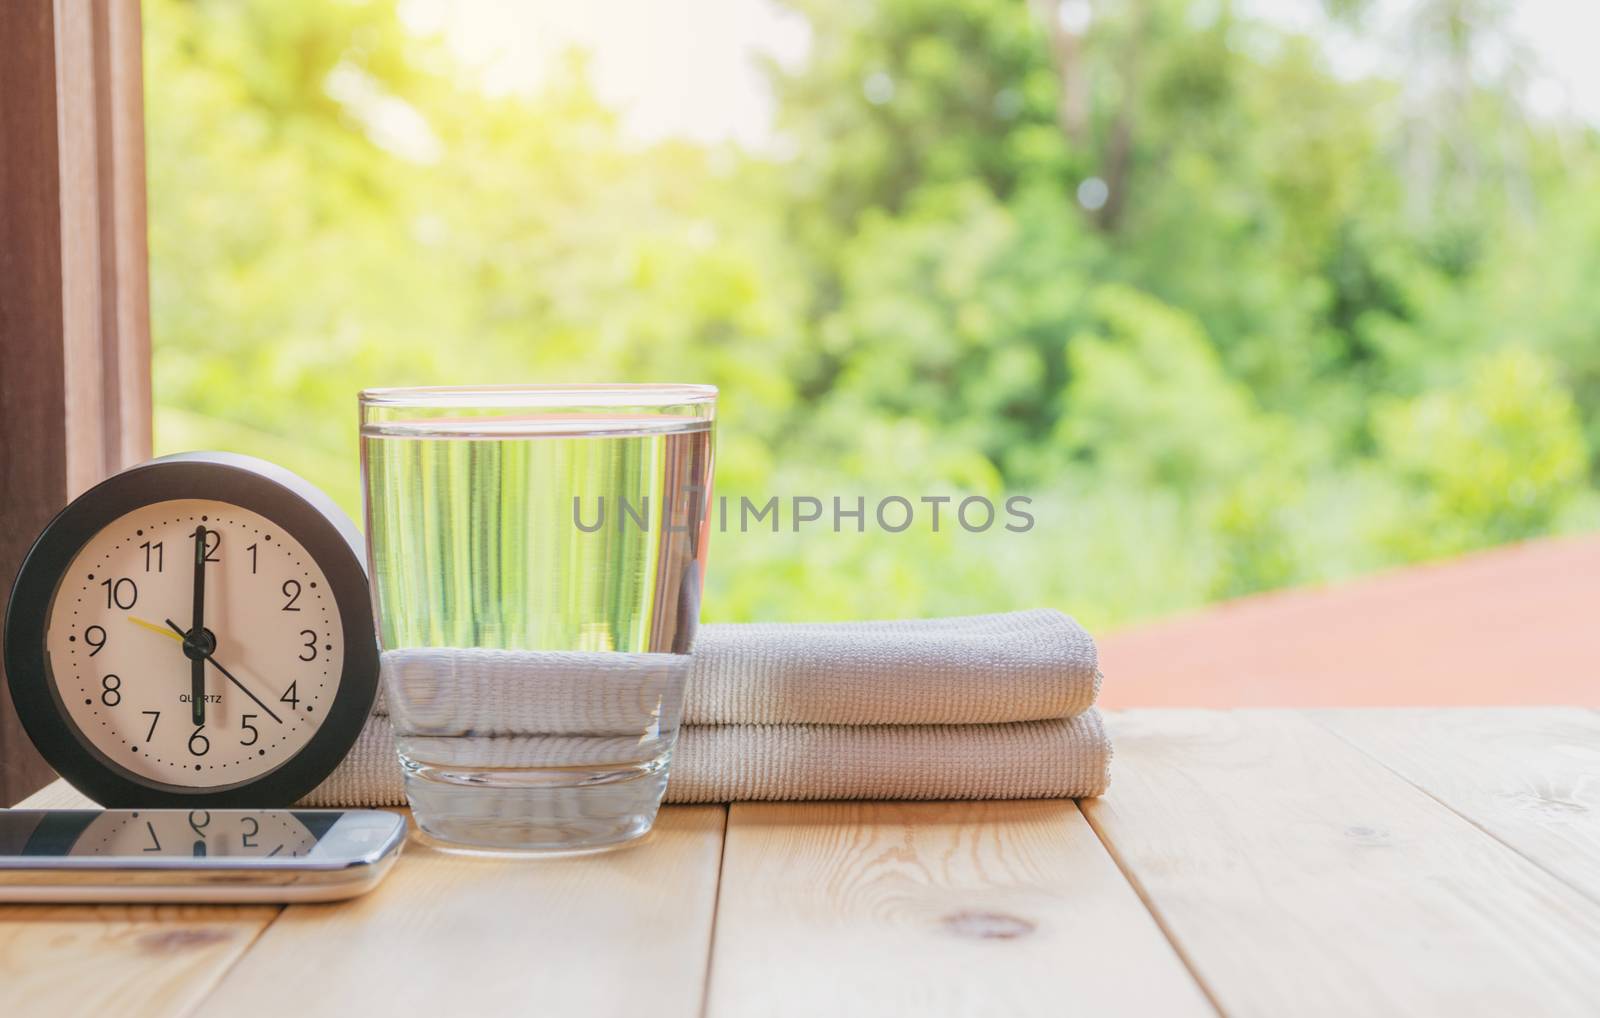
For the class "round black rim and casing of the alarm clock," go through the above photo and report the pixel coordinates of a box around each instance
[5,453,378,808]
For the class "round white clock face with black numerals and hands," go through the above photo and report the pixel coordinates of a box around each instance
[46,499,344,788]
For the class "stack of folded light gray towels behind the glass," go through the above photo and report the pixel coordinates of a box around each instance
[304,610,1110,807]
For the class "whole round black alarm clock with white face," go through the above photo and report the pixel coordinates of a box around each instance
[5,453,378,808]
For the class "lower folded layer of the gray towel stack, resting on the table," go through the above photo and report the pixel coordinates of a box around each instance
[302,709,1110,808]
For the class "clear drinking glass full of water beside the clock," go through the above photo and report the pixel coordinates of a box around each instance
[362,386,717,852]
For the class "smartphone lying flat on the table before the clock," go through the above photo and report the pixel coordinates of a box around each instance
[0,810,406,903]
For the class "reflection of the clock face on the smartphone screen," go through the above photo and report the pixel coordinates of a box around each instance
[72,810,317,858]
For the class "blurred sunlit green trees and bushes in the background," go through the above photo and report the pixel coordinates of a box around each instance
[144,0,1600,626]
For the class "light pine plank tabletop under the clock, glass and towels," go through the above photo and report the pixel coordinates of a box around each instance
[0,709,1600,1018]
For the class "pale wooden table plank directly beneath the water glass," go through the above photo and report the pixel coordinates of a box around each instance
[190,807,726,1018]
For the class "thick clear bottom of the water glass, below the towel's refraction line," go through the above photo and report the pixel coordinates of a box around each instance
[400,755,667,855]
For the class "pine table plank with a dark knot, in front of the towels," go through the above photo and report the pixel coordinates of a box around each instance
[707,800,1213,1018]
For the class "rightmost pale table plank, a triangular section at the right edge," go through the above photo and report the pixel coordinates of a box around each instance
[1310,707,1600,901]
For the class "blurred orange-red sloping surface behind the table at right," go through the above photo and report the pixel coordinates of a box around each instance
[1099,536,1600,707]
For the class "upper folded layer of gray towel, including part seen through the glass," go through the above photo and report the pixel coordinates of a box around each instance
[378,608,1099,731]
